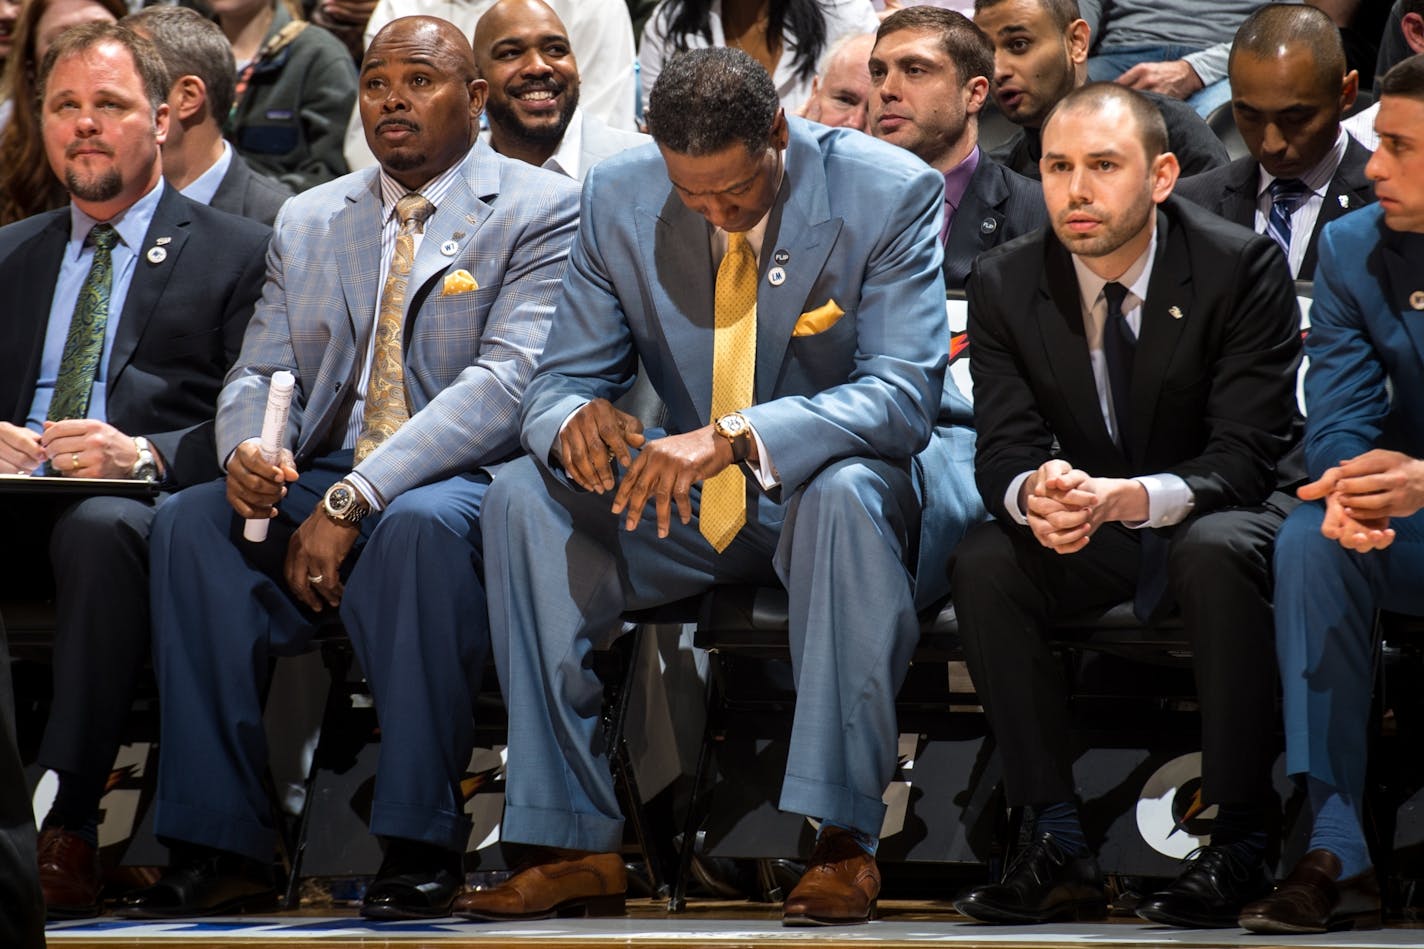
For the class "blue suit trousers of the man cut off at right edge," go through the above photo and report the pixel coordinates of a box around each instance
[1276,502,1424,801]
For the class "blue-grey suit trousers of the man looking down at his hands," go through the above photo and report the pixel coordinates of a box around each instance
[484,457,920,852]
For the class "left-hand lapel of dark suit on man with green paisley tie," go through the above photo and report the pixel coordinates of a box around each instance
[0,216,70,425]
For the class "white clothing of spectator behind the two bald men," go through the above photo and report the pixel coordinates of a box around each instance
[338,0,635,171]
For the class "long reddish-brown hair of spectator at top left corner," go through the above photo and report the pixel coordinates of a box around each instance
[0,0,128,225]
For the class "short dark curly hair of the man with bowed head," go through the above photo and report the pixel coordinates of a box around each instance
[646,46,780,155]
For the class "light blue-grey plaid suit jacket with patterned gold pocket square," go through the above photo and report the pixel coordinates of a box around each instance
[216,142,578,503]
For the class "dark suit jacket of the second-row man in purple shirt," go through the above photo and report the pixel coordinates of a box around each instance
[944,151,1048,289]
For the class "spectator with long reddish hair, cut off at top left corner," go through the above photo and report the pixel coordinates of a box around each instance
[0,0,128,227]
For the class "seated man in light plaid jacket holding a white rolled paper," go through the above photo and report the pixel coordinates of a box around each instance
[122,17,577,919]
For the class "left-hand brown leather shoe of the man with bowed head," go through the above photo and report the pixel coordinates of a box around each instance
[453,849,628,919]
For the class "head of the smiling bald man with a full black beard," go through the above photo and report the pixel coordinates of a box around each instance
[474,0,578,164]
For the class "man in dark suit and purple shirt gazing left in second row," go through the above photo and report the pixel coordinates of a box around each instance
[870,6,1048,289]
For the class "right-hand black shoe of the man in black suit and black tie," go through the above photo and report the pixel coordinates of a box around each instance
[1138,846,1273,929]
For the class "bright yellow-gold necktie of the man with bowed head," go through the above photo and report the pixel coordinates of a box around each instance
[698,232,756,553]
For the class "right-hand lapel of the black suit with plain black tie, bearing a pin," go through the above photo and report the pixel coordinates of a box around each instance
[1128,209,1205,467]
